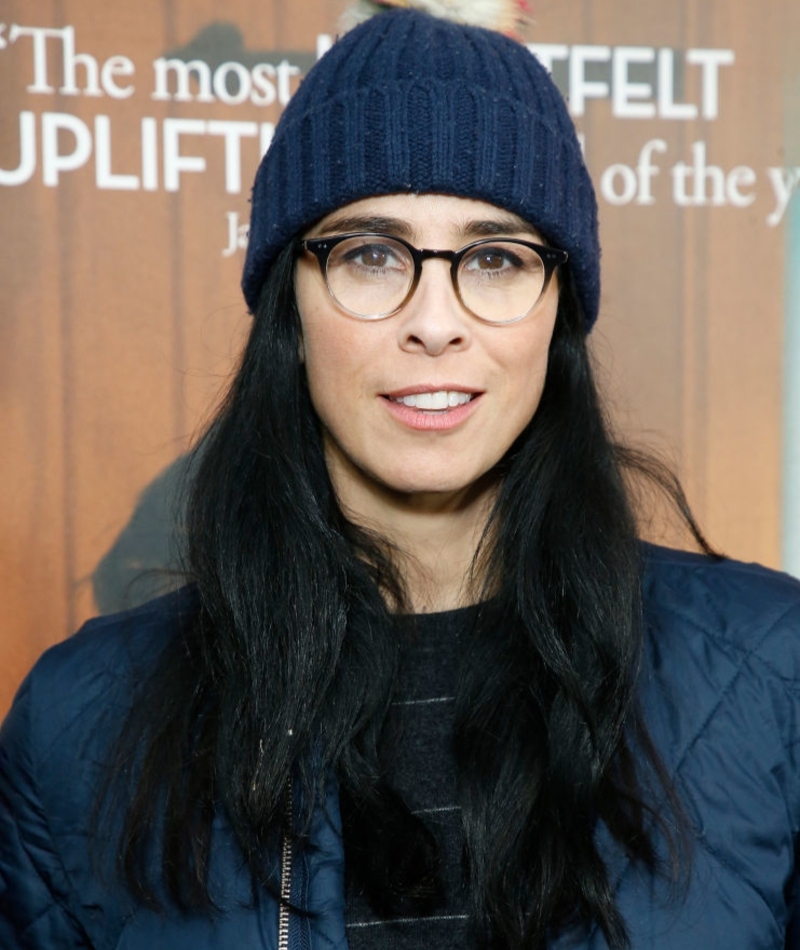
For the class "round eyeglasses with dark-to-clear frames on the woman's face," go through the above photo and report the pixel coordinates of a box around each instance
[298,231,568,324]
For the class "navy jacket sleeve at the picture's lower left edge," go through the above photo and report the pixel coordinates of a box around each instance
[0,677,91,950]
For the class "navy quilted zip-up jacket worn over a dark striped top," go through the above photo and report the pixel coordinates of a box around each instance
[0,547,800,950]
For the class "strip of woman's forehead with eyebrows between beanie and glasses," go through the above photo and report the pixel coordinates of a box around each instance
[306,194,541,245]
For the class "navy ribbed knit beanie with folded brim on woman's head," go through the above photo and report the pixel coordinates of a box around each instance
[242,10,600,331]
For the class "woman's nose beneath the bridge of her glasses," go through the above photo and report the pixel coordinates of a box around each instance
[395,259,472,356]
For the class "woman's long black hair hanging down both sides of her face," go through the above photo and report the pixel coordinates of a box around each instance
[101,249,700,948]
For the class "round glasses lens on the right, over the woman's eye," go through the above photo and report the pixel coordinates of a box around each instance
[458,239,546,323]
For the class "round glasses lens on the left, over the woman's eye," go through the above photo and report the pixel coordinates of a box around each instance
[325,234,414,320]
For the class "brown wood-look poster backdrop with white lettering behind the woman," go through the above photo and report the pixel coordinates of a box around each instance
[0,0,800,714]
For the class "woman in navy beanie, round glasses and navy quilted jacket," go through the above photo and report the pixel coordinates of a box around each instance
[0,10,800,950]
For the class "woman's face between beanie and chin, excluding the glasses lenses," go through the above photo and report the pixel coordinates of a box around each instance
[295,195,558,511]
